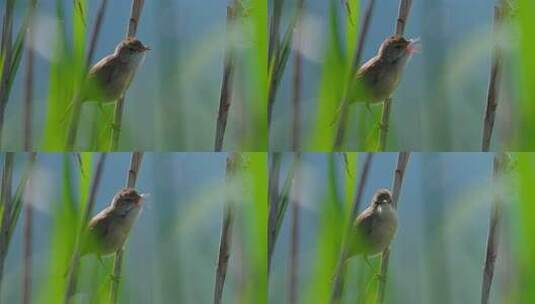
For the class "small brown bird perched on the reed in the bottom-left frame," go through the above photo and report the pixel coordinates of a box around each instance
[80,188,145,258]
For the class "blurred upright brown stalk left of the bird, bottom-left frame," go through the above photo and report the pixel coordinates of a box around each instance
[22,153,37,304]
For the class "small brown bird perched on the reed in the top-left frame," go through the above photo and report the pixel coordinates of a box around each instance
[82,37,150,103]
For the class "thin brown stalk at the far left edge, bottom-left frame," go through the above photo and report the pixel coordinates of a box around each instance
[0,152,14,294]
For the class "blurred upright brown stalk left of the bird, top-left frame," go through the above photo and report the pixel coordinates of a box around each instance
[22,0,37,151]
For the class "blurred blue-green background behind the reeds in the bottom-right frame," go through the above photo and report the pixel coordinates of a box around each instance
[269,153,516,304]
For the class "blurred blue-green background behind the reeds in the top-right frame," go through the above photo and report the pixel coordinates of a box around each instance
[270,0,516,151]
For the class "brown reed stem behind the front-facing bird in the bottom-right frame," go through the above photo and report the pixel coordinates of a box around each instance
[376,152,410,304]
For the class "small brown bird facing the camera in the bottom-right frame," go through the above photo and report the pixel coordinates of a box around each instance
[348,189,398,259]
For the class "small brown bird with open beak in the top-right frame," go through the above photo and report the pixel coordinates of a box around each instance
[348,36,419,104]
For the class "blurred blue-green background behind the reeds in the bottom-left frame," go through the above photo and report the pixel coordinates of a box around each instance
[0,153,260,303]
